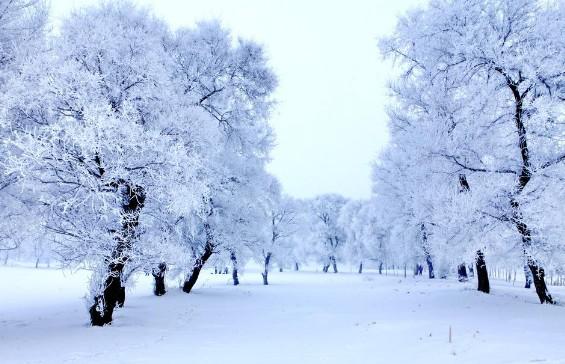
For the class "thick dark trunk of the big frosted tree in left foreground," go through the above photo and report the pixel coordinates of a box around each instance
[89,181,145,326]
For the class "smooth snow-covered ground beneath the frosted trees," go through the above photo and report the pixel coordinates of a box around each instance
[0,267,565,364]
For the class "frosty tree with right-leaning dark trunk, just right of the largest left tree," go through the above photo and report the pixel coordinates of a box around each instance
[169,22,276,292]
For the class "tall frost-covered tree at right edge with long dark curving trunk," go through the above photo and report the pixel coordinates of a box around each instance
[374,0,565,303]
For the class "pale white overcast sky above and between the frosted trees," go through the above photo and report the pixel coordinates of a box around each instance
[51,0,424,198]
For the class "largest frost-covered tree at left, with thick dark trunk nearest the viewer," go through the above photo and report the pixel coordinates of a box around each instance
[2,2,207,325]
